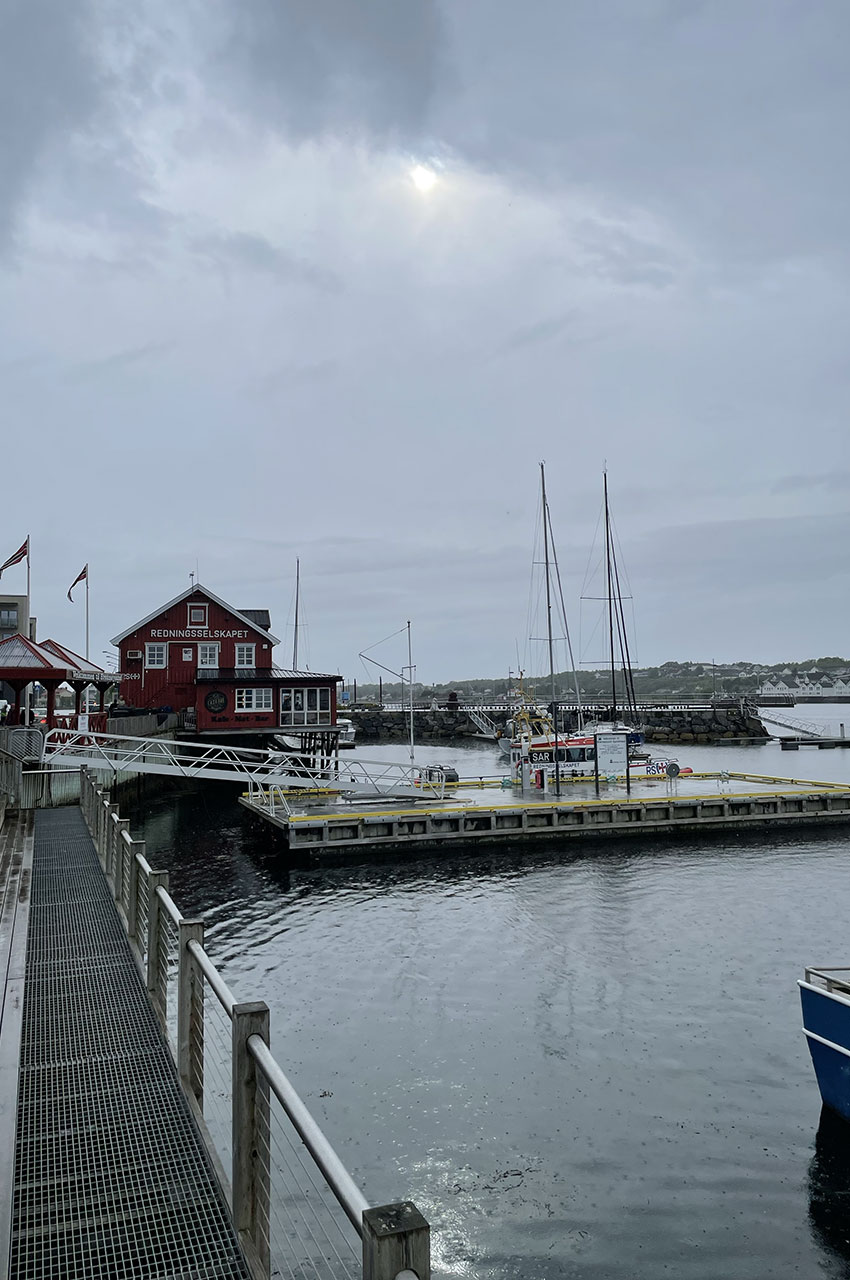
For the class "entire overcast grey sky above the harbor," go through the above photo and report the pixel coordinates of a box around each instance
[0,0,850,681]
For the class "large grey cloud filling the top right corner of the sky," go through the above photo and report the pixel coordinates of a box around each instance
[431,0,850,260]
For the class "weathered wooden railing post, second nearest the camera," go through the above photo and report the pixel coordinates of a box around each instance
[232,1000,271,1280]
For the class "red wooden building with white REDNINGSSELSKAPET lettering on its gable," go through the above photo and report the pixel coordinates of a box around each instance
[113,584,342,740]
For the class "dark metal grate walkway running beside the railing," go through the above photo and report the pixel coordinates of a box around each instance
[9,809,248,1280]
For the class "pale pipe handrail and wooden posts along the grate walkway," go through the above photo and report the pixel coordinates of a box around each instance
[81,768,430,1280]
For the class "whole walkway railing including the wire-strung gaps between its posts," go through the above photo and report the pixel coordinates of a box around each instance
[81,768,430,1280]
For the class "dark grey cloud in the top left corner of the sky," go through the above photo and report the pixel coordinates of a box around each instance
[0,0,99,244]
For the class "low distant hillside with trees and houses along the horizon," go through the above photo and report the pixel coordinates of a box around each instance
[346,658,850,701]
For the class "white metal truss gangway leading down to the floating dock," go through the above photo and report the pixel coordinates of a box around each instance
[42,730,445,800]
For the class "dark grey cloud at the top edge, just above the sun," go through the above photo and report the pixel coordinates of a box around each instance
[218,0,443,138]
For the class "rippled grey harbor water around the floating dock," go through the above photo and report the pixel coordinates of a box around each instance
[131,707,850,1280]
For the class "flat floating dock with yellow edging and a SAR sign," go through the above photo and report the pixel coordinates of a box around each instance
[239,774,850,860]
